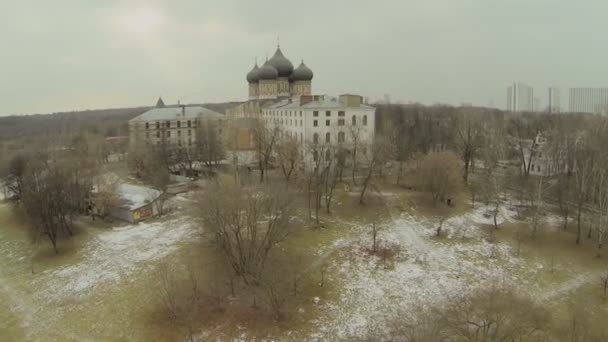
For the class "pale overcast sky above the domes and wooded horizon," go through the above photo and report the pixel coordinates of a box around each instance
[0,0,608,115]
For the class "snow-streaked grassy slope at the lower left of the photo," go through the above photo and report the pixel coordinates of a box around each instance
[0,204,199,341]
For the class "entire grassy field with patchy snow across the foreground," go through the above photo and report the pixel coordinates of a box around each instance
[0,180,608,341]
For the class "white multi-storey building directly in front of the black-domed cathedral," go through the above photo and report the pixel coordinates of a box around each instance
[261,95,375,165]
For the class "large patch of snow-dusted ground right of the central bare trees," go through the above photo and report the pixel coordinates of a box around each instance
[317,204,525,339]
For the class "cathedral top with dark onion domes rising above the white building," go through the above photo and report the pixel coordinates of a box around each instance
[247,46,313,100]
